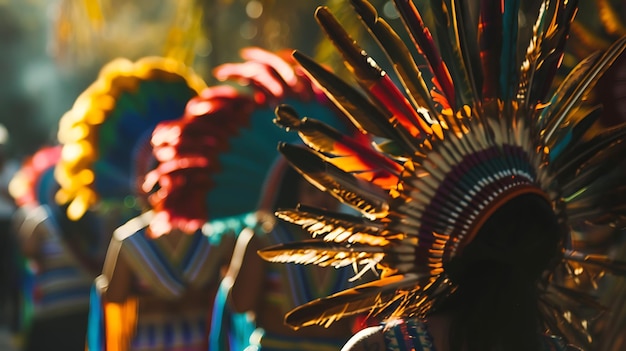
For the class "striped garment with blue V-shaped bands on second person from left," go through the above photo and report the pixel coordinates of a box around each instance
[113,228,219,350]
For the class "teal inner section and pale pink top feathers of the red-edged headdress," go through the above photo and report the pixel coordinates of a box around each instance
[202,47,349,219]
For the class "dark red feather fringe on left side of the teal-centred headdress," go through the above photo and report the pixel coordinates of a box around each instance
[142,86,254,236]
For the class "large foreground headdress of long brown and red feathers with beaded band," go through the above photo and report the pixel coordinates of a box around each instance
[260,0,626,342]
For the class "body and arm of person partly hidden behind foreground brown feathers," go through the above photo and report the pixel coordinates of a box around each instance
[225,162,355,350]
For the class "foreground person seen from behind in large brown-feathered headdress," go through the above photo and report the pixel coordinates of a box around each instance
[261,0,626,351]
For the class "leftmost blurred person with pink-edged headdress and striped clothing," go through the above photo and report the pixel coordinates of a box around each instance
[9,146,111,351]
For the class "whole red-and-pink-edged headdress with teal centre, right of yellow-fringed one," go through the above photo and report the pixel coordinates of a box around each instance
[133,47,352,236]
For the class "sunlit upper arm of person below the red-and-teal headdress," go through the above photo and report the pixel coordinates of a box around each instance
[224,228,265,313]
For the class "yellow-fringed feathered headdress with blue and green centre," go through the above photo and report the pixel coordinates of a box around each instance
[55,57,206,219]
